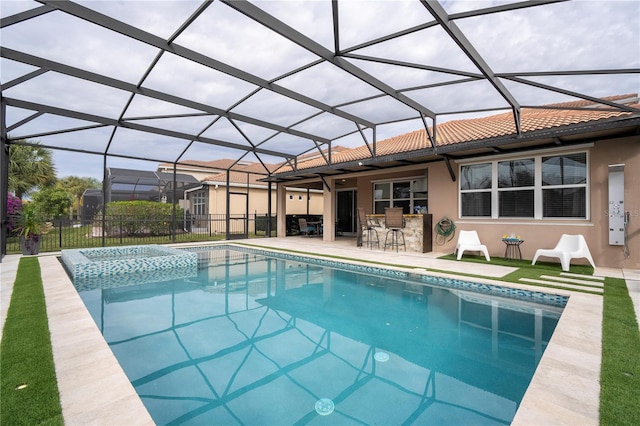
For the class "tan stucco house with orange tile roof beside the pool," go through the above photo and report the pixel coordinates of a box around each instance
[269,94,640,268]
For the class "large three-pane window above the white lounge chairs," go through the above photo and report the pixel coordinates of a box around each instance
[460,152,588,219]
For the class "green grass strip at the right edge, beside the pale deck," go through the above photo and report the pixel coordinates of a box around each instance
[600,278,640,426]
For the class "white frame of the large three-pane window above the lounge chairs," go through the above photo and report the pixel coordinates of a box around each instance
[458,148,593,221]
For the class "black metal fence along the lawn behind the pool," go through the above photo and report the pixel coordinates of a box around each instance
[7,214,276,254]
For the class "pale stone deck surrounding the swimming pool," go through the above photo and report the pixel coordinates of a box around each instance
[0,237,640,425]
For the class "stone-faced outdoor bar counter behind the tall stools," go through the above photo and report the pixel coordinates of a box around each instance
[367,214,433,253]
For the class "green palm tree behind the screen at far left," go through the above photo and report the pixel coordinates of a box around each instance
[9,140,56,199]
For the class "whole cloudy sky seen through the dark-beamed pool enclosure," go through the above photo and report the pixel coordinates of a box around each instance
[0,0,640,178]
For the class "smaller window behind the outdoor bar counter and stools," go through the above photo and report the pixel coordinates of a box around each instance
[373,176,428,214]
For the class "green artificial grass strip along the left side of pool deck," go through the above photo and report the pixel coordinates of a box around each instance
[0,257,64,425]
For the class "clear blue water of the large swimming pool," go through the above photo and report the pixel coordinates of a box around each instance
[75,248,562,425]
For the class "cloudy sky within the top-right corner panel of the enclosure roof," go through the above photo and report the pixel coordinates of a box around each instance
[457,1,640,72]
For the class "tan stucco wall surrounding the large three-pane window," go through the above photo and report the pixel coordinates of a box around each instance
[357,136,640,268]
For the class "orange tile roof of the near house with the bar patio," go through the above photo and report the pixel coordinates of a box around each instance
[276,94,640,174]
